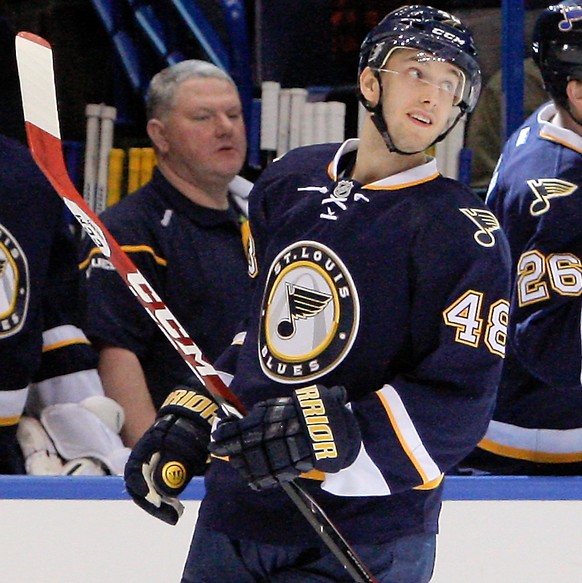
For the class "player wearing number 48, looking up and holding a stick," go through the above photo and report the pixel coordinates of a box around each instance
[125,6,509,583]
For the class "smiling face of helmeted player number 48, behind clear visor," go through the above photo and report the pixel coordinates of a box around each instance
[380,49,463,152]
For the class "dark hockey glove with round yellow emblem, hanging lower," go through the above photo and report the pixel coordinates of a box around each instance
[124,386,218,524]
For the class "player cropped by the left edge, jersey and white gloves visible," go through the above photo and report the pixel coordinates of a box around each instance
[0,136,129,475]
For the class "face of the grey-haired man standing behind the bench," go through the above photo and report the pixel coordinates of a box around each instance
[157,78,247,186]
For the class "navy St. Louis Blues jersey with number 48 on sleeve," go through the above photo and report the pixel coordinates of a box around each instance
[199,140,509,544]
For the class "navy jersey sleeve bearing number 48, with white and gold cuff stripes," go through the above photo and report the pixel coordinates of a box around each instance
[323,196,509,496]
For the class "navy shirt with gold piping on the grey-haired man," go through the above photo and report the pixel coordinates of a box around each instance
[82,169,249,408]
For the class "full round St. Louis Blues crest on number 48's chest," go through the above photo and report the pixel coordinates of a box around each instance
[259,241,360,383]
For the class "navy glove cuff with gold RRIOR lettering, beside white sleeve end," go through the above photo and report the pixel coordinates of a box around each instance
[293,385,362,473]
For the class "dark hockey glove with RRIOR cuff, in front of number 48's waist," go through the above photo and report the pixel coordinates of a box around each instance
[209,385,361,490]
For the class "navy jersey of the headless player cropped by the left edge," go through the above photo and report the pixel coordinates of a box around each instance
[0,136,102,425]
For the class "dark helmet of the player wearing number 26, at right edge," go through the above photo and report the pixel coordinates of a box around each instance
[532,1,582,111]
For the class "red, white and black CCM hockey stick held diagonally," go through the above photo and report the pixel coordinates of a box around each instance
[16,32,376,583]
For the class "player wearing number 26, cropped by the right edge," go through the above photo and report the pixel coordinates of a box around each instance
[463,2,582,474]
